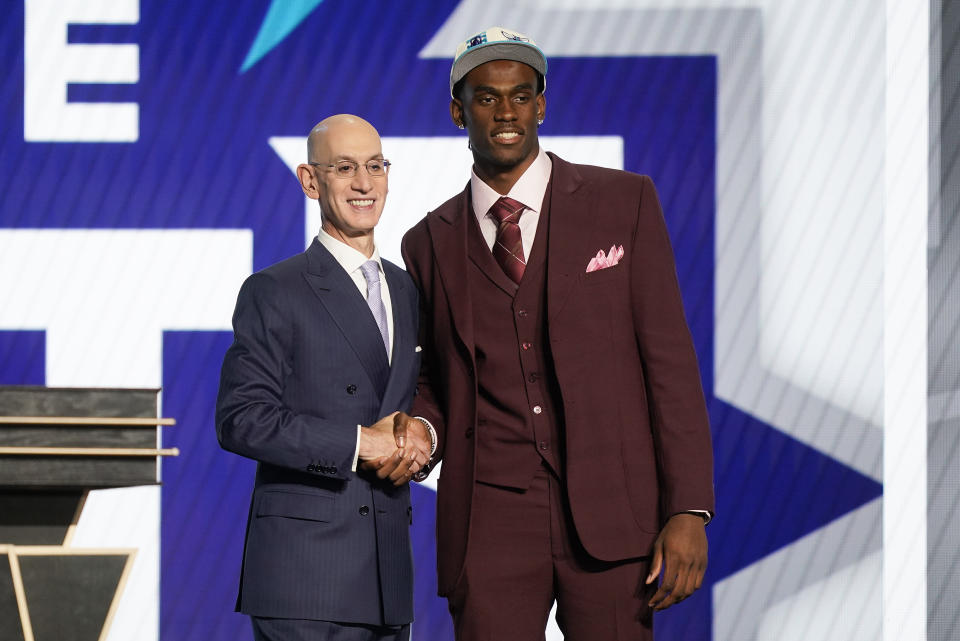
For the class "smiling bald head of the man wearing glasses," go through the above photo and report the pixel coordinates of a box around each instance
[297,116,387,256]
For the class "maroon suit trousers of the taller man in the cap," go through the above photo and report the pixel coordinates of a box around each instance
[448,466,656,641]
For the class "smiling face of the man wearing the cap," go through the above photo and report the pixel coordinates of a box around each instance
[450,60,546,193]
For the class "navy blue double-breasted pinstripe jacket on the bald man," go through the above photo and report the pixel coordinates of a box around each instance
[216,240,420,625]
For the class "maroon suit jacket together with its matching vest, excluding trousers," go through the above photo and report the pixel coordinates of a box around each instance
[403,154,714,632]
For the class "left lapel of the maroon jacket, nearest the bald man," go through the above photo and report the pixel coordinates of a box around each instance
[427,183,474,358]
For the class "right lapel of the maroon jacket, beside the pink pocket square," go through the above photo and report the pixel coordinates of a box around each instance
[547,153,593,320]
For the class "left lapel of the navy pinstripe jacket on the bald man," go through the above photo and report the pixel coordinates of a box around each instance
[303,240,396,398]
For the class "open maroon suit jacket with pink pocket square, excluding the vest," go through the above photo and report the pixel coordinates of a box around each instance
[402,154,714,594]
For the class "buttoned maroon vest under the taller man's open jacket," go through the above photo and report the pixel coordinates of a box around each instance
[467,188,563,489]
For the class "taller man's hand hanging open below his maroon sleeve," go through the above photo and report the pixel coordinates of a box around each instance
[646,514,707,610]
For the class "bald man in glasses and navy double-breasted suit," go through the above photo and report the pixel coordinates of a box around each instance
[216,115,431,641]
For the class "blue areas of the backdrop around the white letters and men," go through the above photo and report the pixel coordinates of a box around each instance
[0,0,881,641]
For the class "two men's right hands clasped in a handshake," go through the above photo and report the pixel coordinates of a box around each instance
[358,412,433,485]
